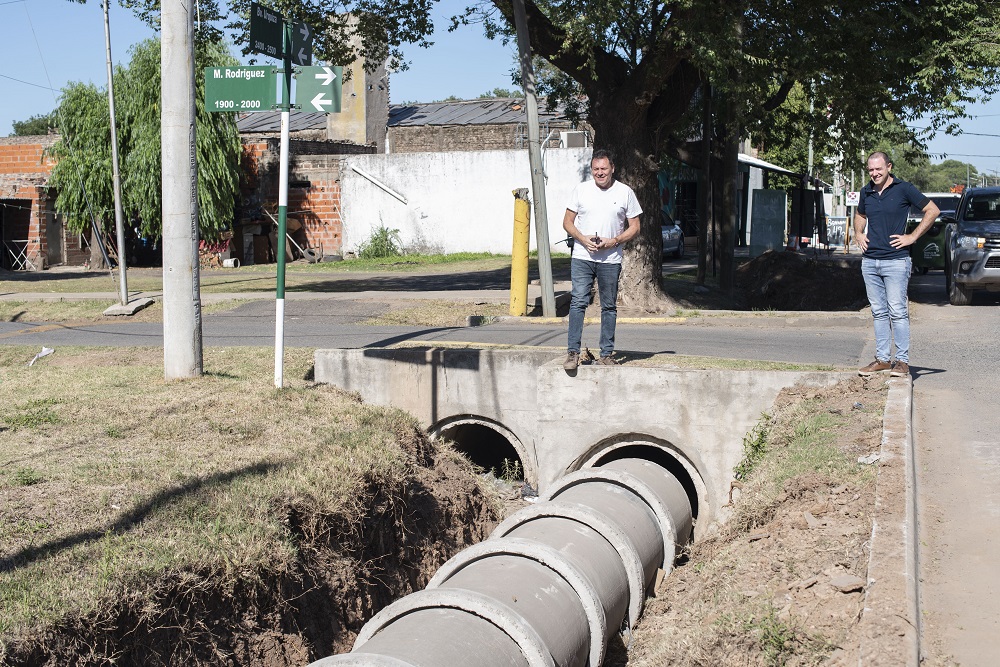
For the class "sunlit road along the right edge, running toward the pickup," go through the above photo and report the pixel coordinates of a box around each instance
[910,272,1000,667]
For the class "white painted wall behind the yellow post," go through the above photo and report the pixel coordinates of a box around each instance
[340,148,593,254]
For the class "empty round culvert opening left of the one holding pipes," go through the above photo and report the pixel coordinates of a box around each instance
[429,416,526,479]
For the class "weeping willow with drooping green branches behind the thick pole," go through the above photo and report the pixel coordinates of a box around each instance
[50,39,241,265]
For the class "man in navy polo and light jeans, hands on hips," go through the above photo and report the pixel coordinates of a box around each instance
[854,152,941,377]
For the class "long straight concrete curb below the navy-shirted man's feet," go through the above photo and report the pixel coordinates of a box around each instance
[858,378,920,667]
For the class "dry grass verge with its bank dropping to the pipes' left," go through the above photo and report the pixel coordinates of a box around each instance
[0,346,496,665]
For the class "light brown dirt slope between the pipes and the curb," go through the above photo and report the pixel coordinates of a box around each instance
[605,378,885,667]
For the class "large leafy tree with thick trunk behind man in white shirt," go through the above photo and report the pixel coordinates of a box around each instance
[123,0,1000,308]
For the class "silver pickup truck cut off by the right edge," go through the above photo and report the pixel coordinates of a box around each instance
[944,187,1000,306]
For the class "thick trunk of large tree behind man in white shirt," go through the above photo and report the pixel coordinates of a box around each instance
[590,91,677,313]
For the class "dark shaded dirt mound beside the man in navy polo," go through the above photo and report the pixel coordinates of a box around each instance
[736,250,868,311]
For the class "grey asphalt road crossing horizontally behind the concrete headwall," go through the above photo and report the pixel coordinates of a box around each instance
[0,301,869,366]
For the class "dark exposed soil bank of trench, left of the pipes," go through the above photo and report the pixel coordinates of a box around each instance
[0,429,502,667]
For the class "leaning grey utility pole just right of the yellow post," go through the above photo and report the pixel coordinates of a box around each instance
[514,0,556,317]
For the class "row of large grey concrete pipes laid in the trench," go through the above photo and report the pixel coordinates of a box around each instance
[311,458,693,667]
